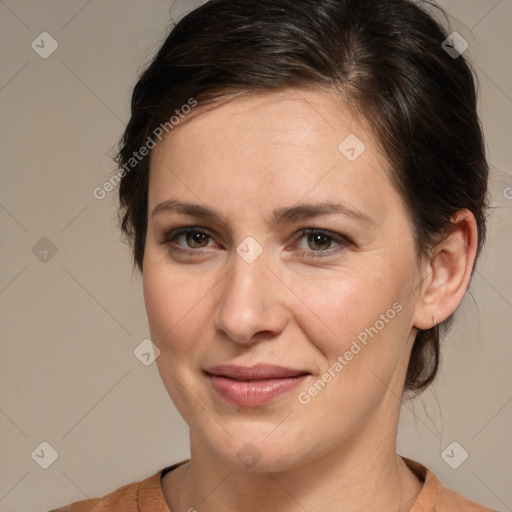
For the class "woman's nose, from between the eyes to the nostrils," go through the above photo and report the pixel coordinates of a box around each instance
[214,247,289,345]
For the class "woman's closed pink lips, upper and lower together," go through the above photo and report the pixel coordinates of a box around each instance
[205,364,310,407]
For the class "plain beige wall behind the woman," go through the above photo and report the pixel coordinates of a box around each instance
[0,0,512,512]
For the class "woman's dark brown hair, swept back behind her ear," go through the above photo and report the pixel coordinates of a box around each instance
[117,0,489,394]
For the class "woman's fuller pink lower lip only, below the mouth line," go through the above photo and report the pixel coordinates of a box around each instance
[208,375,308,407]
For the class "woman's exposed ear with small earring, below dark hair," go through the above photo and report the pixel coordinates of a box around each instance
[413,208,478,330]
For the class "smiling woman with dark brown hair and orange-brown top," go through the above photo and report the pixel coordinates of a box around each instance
[53,0,500,512]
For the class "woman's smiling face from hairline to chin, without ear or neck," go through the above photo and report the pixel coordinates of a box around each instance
[143,90,419,471]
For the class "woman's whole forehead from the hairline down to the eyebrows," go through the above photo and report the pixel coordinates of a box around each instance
[149,89,393,226]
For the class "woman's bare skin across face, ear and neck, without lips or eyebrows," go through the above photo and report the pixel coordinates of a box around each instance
[143,86,477,512]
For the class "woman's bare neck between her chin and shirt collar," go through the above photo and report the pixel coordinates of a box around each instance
[164,408,422,512]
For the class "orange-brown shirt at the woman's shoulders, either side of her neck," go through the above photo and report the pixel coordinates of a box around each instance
[49,457,497,512]
